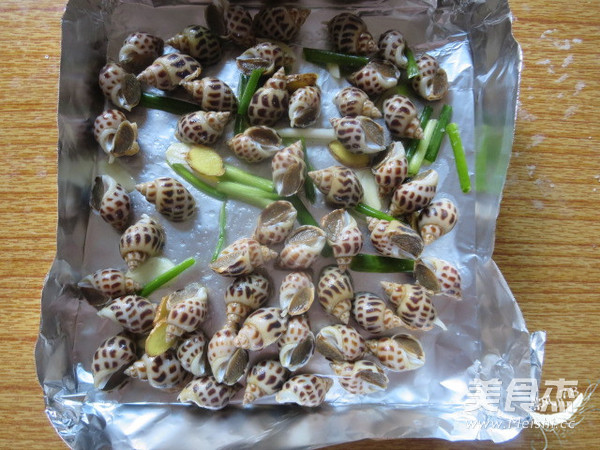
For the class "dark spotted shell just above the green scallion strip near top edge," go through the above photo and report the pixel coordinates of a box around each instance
[327,13,377,55]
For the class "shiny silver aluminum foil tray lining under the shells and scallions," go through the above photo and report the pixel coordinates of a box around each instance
[36,0,545,449]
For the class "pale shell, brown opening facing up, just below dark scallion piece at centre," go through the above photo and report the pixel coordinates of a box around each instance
[277,225,327,270]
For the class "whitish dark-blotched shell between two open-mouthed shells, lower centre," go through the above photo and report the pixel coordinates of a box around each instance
[233,307,288,351]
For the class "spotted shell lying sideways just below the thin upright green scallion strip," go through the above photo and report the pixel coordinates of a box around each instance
[210,238,277,277]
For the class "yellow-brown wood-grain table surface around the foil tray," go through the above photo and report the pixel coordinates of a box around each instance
[0,0,600,450]
